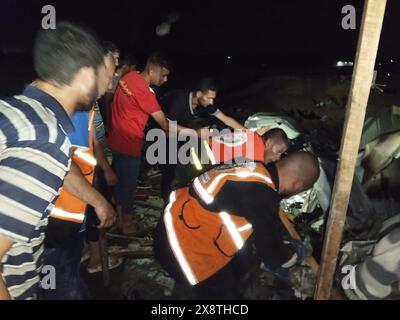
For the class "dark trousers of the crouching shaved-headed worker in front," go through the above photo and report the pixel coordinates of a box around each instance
[154,222,258,299]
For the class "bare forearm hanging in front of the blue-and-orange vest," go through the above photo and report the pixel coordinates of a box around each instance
[64,161,116,228]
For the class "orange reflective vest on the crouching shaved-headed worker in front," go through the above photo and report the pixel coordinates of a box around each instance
[163,162,275,285]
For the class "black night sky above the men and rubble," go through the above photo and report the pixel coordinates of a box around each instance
[0,0,400,79]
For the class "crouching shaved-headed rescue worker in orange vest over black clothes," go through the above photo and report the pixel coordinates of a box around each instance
[154,151,319,298]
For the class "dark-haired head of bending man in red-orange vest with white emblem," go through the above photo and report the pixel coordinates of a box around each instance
[262,128,289,163]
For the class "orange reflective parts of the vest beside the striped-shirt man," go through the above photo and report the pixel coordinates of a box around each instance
[50,108,96,223]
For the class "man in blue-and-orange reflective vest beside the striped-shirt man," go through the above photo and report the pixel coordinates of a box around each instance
[43,46,116,300]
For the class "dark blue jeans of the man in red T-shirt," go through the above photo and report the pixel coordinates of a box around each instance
[112,152,141,214]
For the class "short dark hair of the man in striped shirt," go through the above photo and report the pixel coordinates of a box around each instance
[33,22,104,85]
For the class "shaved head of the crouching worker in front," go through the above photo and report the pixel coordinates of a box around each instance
[276,151,320,197]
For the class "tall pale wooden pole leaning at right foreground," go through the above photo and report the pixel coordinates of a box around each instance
[315,0,386,300]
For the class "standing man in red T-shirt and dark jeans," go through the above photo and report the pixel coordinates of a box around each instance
[108,55,178,235]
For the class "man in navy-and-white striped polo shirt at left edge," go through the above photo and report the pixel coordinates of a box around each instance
[0,23,103,299]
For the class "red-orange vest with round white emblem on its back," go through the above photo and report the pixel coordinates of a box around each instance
[208,130,265,163]
